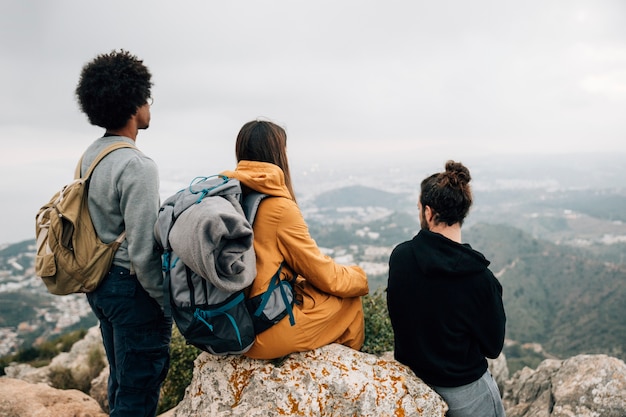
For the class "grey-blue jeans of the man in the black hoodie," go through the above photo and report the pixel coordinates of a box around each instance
[431,371,505,417]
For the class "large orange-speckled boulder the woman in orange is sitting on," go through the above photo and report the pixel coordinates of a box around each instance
[174,344,448,417]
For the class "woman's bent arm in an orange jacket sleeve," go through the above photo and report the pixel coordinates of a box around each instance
[277,199,369,297]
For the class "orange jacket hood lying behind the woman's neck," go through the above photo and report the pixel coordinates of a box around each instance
[222,160,291,199]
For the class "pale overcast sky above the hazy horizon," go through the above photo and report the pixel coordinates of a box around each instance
[0,0,626,244]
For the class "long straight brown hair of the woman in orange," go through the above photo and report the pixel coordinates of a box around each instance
[235,120,296,201]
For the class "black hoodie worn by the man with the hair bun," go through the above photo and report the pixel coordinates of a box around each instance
[387,230,506,387]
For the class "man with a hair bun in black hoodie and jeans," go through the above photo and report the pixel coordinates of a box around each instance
[387,161,506,417]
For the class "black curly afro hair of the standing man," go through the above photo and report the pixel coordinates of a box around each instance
[76,49,152,130]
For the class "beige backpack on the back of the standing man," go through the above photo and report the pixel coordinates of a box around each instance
[35,142,134,295]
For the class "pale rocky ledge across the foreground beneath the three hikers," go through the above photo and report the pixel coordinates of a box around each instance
[0,328,626,417]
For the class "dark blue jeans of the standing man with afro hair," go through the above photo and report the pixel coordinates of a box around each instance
[87,265,172,417]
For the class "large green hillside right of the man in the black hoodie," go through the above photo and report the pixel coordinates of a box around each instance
[463,224,626,359]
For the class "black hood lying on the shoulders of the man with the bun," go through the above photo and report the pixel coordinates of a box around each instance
[411,230,489,277]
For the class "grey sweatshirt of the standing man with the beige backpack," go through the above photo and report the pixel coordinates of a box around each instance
[81,136,163,306]
